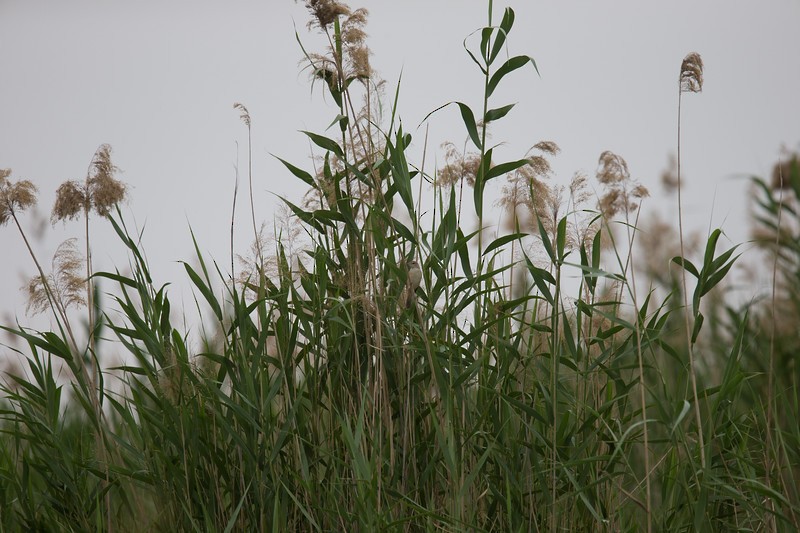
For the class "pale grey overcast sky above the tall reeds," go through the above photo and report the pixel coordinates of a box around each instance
[0,0,800,340]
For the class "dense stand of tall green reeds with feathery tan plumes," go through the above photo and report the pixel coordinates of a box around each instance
[0,4,800,531]
